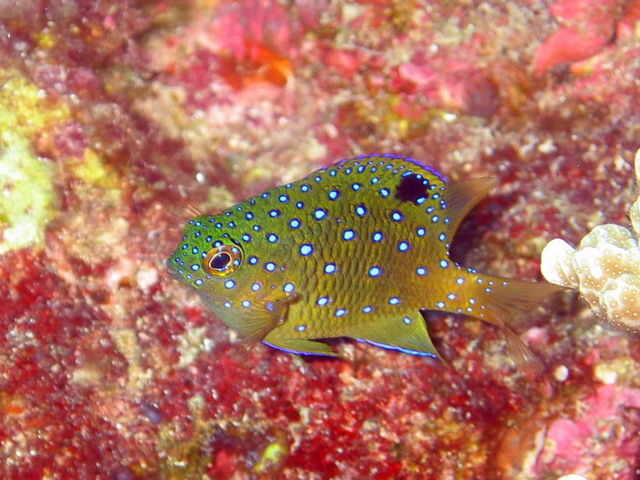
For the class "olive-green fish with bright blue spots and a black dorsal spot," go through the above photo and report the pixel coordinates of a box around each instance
[166,154,562,363]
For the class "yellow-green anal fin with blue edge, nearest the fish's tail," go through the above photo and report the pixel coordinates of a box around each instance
[349,311,440,357]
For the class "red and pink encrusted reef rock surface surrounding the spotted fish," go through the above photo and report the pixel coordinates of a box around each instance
[0,0,640,480]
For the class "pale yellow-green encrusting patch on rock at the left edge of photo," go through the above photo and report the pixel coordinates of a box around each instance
[0,69,69,254]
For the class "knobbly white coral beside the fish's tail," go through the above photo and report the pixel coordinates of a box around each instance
[541,150,640,330]
